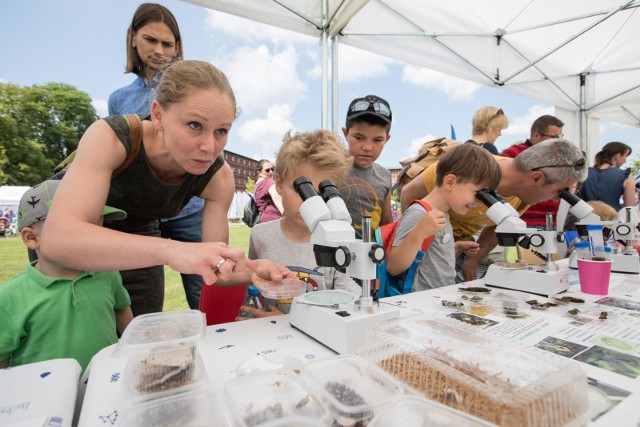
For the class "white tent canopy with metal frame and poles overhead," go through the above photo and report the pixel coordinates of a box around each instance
[185,0,640,158]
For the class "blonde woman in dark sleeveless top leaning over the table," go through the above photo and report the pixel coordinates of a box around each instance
[41,61,293,315]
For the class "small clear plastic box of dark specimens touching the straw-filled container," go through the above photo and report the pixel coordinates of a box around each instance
[304,355,406,426]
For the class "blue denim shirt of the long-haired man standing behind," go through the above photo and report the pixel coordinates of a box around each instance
[109,76,204,221]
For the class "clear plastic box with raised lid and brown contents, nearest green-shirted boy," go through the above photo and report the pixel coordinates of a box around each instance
[116,310,205,400]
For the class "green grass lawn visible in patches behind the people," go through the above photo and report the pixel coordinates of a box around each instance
[0,223,250,311]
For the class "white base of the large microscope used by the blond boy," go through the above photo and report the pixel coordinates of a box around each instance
[289,295,400,354]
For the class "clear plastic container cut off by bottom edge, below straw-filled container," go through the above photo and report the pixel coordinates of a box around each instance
[368,396,495,427]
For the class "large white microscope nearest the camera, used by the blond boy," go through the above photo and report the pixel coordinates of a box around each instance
[289,176,400,354]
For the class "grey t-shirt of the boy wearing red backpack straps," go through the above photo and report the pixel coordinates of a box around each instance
[393,203,456,292]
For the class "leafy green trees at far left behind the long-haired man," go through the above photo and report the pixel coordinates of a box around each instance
[0,83,98,185]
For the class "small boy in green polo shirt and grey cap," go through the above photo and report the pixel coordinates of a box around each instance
[0,180,133,370]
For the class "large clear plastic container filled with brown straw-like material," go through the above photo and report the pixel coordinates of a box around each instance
[359,315,588,426]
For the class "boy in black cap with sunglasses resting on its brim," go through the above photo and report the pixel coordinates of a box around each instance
[340,95,393,238]
